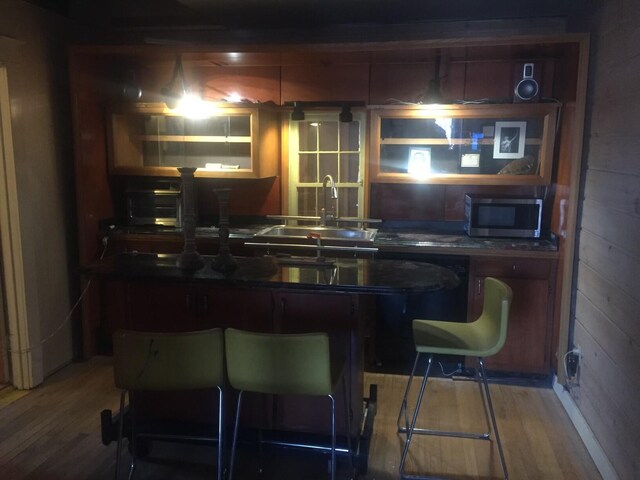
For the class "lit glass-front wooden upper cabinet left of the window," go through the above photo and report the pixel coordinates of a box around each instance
[110,104,280,178]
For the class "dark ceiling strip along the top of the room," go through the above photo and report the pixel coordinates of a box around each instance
[28,0,588,30]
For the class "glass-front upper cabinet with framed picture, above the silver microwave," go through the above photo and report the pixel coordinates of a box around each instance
[370,103,558,185]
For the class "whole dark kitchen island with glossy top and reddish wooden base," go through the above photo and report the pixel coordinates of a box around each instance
[83,253,459,469]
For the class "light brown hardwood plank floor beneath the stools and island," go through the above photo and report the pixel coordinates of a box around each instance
[0,357,600,480]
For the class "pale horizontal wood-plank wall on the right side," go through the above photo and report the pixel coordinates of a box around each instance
[571,0,640,480]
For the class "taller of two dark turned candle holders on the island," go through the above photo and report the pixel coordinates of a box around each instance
[176,167,204,270]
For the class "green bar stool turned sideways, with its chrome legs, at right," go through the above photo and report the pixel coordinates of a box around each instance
[398,277,512,479]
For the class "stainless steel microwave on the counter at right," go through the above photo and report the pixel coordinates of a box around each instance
[464,194,542,238]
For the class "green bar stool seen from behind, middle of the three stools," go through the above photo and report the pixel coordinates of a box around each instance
[225,328,351,480]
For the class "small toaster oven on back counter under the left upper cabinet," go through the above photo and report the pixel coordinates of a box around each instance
[125,183,182,227]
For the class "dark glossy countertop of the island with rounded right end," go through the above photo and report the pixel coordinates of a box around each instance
[81,253,460,294]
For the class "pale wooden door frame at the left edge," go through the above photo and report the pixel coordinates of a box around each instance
[0,64,35,389]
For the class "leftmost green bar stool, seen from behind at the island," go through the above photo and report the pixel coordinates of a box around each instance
[113,328,224,480]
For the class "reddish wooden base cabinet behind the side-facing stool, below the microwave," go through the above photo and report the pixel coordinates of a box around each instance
[468,257,556,375]
